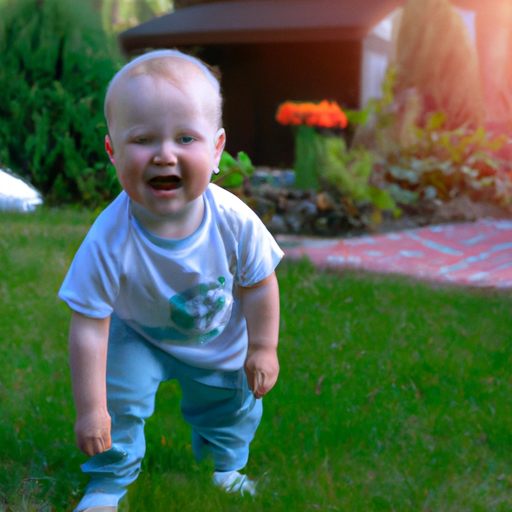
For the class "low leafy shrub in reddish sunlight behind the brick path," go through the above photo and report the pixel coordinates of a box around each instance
[380,112,512,207]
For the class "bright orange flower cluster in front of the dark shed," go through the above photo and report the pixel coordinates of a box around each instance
[276,100,348,128]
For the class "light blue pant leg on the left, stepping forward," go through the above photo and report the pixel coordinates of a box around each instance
[77,315,173,510]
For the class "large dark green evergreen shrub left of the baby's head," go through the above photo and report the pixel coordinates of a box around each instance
[0,0,119,206]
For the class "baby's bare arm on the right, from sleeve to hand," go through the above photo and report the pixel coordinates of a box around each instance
[240,272,279,398]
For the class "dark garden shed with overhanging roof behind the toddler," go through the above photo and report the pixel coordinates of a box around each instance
[119,0,512,166]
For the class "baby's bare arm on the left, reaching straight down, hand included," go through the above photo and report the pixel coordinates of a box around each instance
[69,311,111,457]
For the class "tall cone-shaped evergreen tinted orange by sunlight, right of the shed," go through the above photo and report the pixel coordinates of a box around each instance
[395,0,484,129]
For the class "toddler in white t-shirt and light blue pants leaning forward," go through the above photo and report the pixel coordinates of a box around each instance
[59,50,283,512]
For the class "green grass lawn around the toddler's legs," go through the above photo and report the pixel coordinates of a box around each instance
[0,209,512,512]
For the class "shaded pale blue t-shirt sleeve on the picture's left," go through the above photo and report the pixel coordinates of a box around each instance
[58,233,119,318]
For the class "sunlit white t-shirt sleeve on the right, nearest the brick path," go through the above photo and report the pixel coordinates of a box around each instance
[238,207,284,286]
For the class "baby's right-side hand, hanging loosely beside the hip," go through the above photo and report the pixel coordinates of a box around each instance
[245,345,279,398]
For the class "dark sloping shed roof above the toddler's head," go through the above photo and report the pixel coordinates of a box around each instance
[119,0,406,53]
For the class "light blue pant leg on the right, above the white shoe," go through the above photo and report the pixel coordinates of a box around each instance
[177,364,262,471]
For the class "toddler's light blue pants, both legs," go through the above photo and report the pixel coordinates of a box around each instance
[76,315,262,510]
